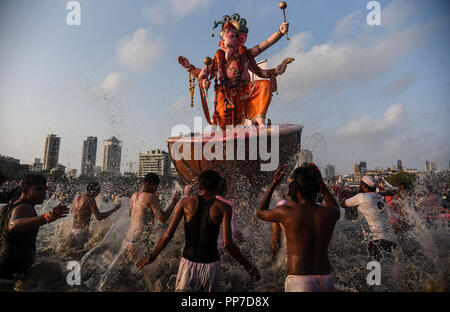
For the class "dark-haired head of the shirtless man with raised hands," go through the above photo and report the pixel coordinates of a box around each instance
[289,164,320,202]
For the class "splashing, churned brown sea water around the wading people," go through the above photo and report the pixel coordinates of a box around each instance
[14,178,450,292]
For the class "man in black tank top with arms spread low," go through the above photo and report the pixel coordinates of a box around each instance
[136,170,261,292]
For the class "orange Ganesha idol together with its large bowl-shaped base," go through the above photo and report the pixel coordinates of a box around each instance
[172,14,303,195]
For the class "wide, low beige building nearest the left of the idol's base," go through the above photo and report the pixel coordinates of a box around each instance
[139,149,172,178]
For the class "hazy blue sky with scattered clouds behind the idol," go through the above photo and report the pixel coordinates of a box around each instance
[0,0,450,173]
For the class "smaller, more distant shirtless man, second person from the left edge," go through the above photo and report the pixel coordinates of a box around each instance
[71,182,121,248]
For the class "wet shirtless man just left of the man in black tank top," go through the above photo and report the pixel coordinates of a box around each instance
[126,173,181,260]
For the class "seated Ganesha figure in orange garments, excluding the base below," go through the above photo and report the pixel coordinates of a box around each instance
[178,14,293,128]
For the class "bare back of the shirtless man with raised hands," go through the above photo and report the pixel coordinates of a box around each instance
[280,201,339,275]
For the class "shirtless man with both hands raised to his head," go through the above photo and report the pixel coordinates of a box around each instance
[256,163,340,292]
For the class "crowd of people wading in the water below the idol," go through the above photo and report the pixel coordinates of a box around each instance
[0,163,449,292]
